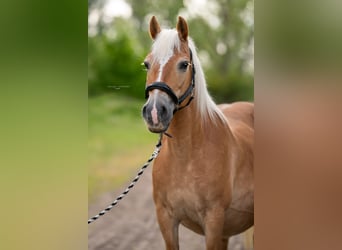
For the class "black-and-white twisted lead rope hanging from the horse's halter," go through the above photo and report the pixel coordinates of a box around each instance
[88,134,162,224]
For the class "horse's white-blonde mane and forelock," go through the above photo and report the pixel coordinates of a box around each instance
[152,29,227,123]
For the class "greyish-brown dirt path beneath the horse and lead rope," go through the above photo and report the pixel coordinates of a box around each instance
[88,166,250,250]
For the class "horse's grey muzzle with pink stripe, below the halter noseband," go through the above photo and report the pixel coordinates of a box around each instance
[142,90,175,133]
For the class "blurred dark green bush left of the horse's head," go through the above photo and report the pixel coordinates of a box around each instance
[88,20,146,98]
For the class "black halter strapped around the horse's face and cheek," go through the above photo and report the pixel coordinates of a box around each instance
[145,49,196,113]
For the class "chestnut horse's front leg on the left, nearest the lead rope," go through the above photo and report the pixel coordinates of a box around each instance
[156,204,179,250]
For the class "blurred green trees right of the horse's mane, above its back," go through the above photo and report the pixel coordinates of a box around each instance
[184,0,254,102]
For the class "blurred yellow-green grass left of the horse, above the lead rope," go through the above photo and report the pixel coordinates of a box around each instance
[88,93,158,200]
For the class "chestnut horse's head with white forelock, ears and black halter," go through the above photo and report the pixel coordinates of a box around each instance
[142,16,195,133]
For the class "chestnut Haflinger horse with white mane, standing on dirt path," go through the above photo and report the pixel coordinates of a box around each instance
[142,16,254,250]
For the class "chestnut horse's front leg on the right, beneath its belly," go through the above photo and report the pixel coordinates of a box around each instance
[204,208,228,250]
